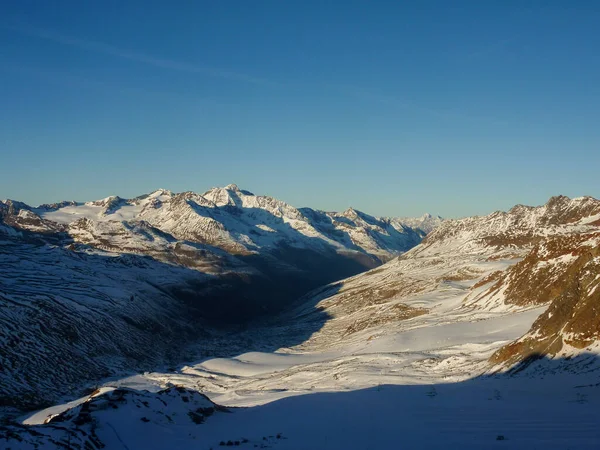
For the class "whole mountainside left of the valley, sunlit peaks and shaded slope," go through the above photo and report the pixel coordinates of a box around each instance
[0,185,439,408]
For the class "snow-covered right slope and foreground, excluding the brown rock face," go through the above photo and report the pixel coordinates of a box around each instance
[0,193,600,449]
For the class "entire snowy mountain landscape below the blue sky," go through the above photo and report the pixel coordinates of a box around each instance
[0,185,600,449]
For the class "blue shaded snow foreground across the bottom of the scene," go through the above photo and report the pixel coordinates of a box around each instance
[5,361,600,450]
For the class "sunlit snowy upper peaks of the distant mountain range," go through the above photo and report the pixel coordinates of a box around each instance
[22,184,441,264]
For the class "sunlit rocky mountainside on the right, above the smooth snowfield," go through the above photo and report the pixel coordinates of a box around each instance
[294,196,600,358]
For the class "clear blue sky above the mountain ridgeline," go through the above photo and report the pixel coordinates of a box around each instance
[0,0,600,217]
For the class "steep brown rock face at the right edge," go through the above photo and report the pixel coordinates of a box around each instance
[492,232,600,364]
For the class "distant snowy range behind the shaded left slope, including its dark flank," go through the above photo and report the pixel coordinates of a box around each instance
[0,184,442,314]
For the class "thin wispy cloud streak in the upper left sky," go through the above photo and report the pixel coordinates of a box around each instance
[1,20,281,86]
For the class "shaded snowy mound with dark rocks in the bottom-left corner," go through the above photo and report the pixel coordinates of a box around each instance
[0,387,230,450]
